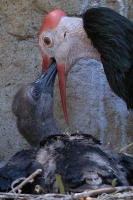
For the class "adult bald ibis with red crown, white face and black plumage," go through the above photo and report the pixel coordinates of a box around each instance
[38,7,133,123]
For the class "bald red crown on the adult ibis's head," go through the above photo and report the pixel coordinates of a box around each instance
[39,10,67,35]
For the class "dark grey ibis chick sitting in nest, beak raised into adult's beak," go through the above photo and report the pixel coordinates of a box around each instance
[0,63,130,193]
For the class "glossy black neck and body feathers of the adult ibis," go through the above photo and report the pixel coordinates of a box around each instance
[83,7,133,109]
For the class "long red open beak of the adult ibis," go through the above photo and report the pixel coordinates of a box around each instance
[42,55,69,124]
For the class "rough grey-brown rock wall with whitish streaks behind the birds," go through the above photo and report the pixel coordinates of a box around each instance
[0,0,133,160]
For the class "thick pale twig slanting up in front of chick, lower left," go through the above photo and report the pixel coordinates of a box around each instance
[9,169,42,193]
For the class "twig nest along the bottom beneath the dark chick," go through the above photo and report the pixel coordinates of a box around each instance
[0,169,133,200]
